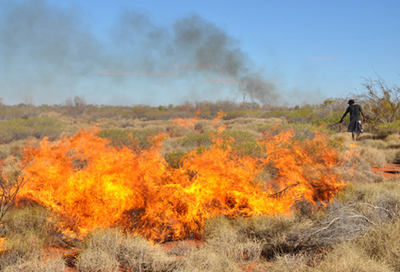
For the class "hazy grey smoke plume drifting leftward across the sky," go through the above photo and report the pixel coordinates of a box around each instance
[0,0,278,105]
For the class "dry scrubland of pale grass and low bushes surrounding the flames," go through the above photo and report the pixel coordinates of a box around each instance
[0,81,400,272]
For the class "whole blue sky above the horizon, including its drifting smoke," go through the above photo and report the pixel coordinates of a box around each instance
[0,0,400,106]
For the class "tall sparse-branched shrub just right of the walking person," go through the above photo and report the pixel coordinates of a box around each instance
[363,77,400,127]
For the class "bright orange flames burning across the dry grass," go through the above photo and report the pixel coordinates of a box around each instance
[19,124,344,241]
